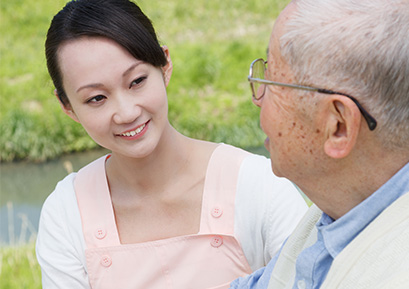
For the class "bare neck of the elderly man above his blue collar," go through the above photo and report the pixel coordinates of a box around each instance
[300,148,409,220]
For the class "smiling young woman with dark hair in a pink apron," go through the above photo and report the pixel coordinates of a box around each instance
[37,0,306,289]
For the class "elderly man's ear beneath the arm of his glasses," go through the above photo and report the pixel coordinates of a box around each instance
[324,95,361,159]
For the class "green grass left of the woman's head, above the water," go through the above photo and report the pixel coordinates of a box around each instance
[0,0,95,161]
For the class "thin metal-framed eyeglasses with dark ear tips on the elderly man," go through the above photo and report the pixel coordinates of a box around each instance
[248,58,377,130]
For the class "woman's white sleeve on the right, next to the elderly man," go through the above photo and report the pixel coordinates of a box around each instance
[234,155,308,271]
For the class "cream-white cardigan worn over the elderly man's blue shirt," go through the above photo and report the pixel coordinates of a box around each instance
[268,192,409,289]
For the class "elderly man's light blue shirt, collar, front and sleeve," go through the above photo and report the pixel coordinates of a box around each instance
[230,163,409,289]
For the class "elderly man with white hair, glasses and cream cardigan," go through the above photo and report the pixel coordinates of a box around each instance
[231,0,409,289]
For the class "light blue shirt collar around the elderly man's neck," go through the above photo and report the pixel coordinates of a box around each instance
[317,163,409,258]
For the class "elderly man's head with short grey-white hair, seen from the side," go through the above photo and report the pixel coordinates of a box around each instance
[250,0,409,216]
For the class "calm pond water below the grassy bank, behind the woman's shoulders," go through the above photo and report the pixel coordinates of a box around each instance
[0,147,268,246]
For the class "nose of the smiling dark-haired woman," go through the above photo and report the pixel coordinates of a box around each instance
[113,97,142,124]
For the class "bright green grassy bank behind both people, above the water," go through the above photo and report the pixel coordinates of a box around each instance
[0,0,288,162]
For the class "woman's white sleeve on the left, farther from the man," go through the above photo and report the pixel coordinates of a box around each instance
[36,174,91,289]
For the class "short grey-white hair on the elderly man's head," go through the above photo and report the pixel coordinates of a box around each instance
[280,0,409,148]
